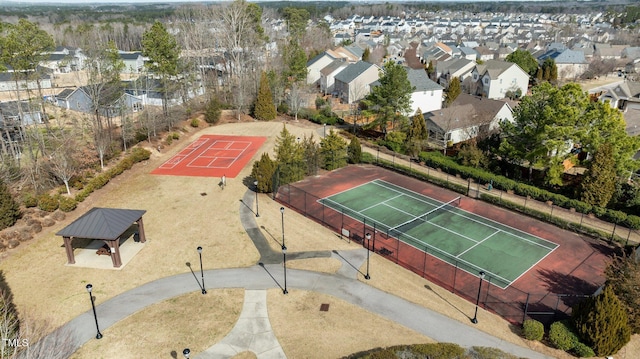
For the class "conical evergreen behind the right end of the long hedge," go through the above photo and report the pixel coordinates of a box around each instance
[581,143,617,208]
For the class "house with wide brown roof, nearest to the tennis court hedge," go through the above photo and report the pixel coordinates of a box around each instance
[424,94,513,147]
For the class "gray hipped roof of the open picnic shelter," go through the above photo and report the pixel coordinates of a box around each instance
[56,207,147,240]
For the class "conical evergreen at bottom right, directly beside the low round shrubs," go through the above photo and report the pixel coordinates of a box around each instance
[571,286,631,356]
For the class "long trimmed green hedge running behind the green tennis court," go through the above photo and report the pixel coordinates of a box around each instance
[419,152,640,229]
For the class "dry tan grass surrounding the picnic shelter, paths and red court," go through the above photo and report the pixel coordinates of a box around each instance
[0,117,640,358]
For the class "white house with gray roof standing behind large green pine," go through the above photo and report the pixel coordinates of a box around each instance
[407,69,444,116]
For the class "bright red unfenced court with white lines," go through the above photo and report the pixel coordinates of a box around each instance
[151,135,267,178]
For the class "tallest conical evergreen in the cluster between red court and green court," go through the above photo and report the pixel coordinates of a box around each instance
[274,125,307,186]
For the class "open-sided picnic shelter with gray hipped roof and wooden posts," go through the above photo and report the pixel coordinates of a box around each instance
[56,207,147,268]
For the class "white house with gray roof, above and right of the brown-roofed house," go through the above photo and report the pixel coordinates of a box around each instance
[469,60,529,99]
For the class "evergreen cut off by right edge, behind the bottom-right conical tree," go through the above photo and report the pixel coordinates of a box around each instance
[605,251,640,334]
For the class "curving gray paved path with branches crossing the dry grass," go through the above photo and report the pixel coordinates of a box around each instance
[53,192,547,359]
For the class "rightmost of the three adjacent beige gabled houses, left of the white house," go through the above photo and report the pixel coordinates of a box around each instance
[333,61,380,104]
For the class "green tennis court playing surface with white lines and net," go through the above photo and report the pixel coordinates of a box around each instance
[320,180,558,288]
